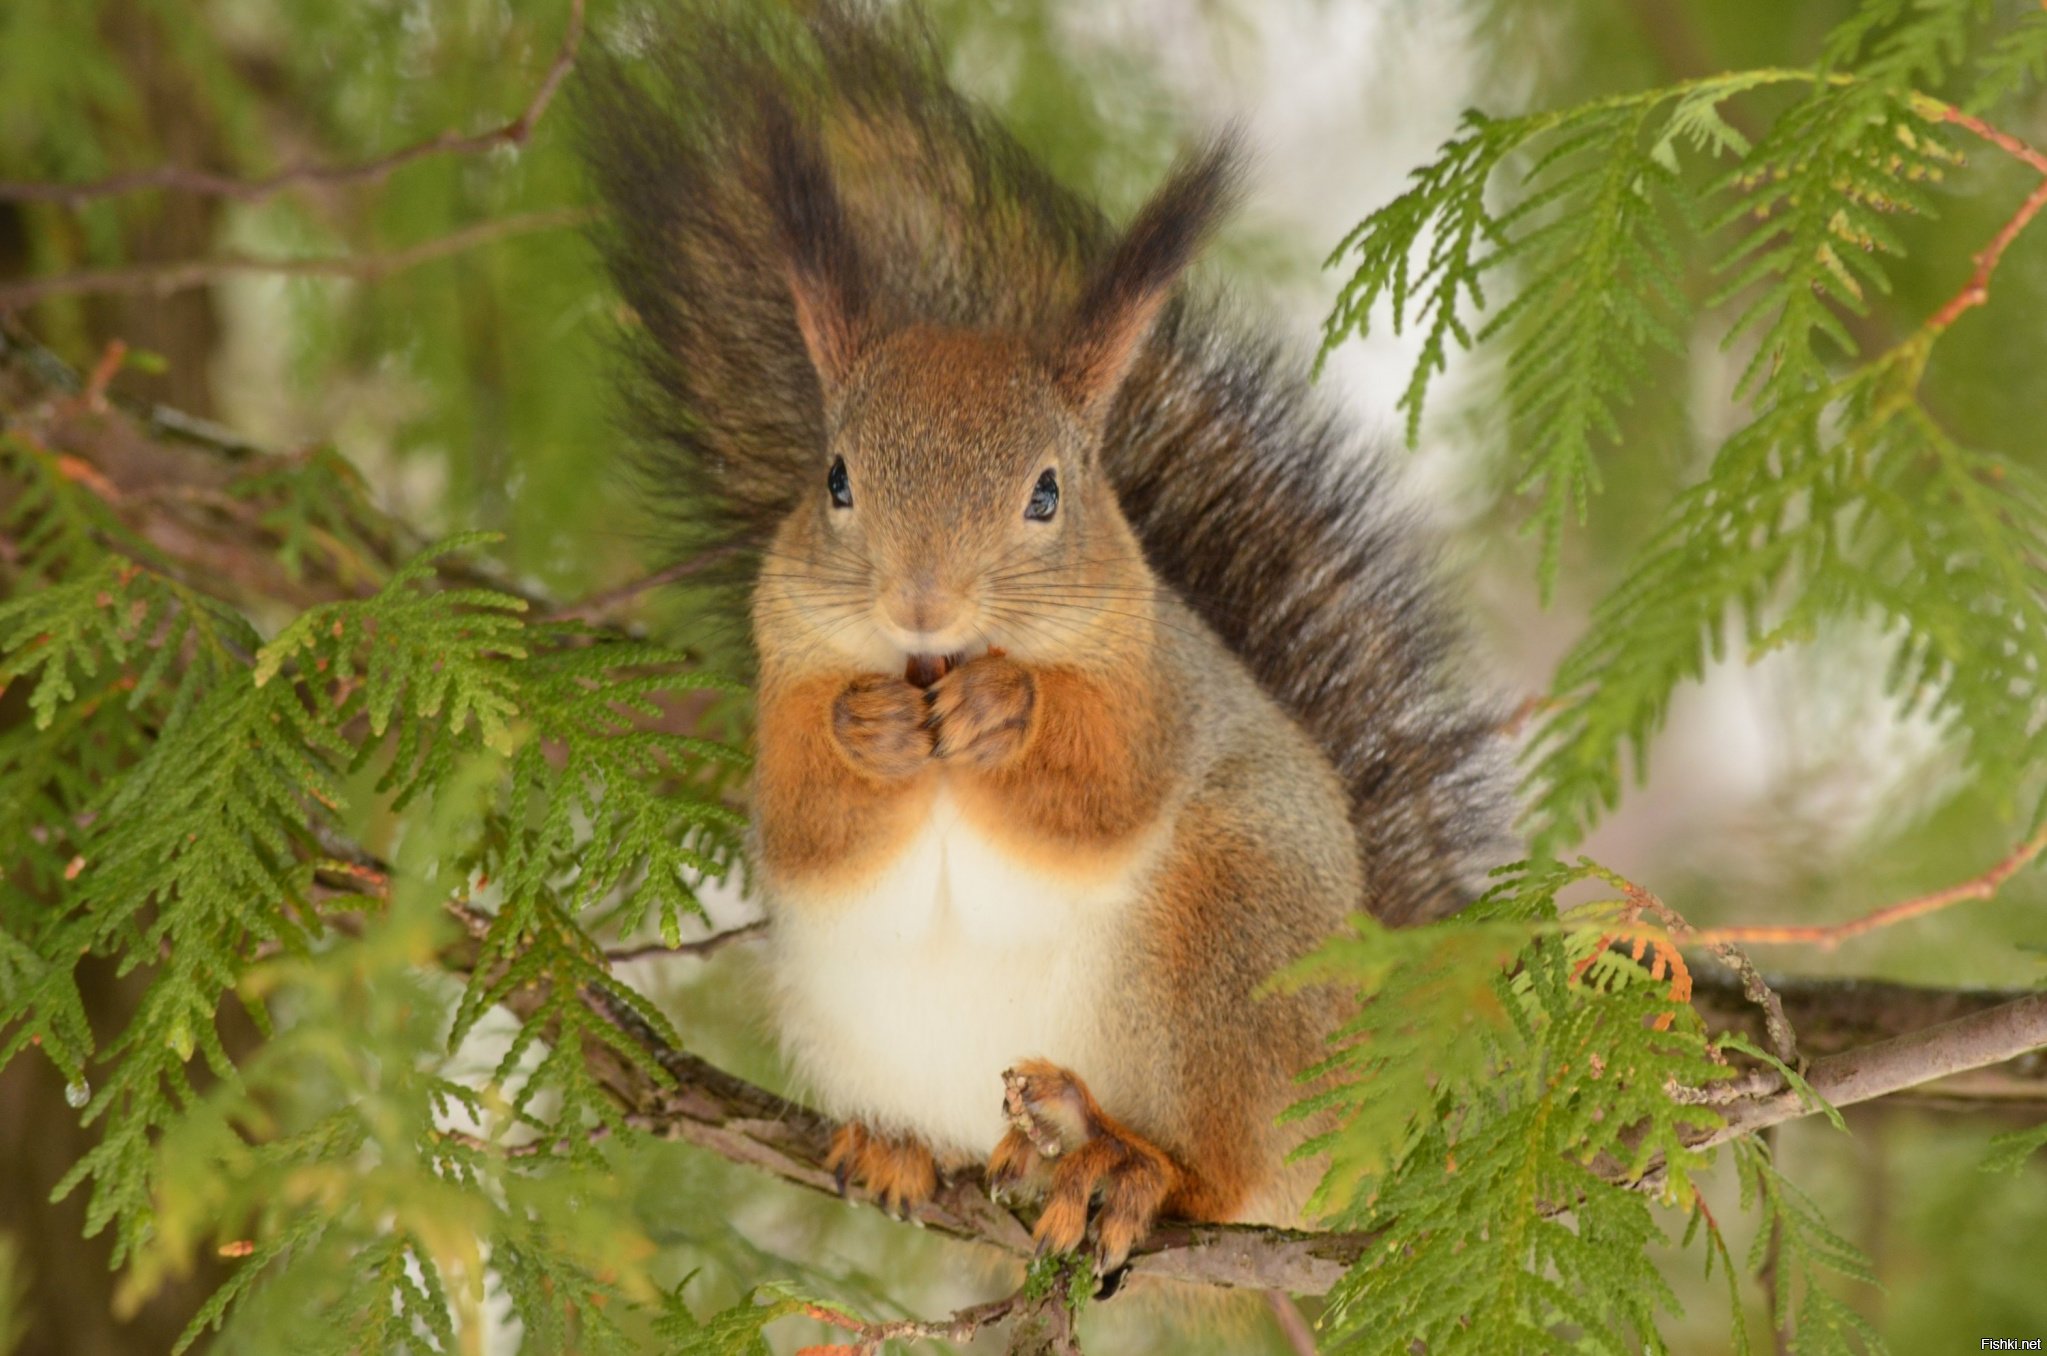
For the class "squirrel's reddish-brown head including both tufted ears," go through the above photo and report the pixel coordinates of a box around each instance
[755,102,1234,672]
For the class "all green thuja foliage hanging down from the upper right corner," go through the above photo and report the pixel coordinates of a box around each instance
[1326,0,2047,846]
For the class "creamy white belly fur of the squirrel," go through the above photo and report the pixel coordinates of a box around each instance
[770,791,1163,1155]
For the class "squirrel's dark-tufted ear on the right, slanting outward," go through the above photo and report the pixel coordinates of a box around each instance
[1050,133,1240,416]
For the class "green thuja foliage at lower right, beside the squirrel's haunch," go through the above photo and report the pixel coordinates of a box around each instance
[1290,862,1846,1352]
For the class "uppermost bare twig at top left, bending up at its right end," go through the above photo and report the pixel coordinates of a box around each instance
[0,0,583,207]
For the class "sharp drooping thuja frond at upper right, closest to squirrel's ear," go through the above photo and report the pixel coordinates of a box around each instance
[1322,70,1812,588]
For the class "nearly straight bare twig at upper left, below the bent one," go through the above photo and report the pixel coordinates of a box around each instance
[0,207,596,311]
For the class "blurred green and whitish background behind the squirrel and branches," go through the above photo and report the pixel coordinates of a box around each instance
[0,0,2047,1354]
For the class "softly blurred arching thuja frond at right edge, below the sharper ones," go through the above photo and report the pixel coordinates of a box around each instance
[1529,340,2047,842]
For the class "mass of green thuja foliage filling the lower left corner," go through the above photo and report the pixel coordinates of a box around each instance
[0,438,743,1352]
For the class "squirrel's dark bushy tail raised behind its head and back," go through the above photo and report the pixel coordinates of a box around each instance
[579,0,1507,922]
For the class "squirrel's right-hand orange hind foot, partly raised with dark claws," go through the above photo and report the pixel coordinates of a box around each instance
[989,1059,1181,1274]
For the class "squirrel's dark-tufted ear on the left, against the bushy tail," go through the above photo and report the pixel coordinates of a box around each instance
[761,100,868,399]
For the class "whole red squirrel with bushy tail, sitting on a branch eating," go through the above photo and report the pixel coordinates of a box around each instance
[579,0,1509,1274]
